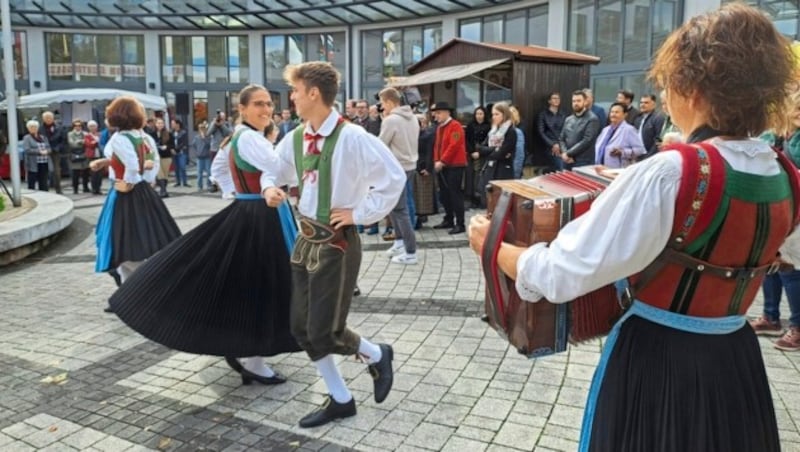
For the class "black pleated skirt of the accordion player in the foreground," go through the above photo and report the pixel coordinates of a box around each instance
[592,316,780,452]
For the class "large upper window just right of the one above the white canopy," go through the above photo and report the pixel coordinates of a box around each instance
[161,36,250,84]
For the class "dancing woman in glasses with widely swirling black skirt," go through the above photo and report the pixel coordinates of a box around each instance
[110,85,300,385]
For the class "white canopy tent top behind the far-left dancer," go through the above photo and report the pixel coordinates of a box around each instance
[0,88,167,111]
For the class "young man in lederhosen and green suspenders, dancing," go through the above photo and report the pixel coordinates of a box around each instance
[262,62,406,427]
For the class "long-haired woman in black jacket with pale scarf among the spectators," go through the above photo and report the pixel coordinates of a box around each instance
[472,102,517,206]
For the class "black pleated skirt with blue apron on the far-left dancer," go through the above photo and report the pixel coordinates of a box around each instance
[97,181,181,271]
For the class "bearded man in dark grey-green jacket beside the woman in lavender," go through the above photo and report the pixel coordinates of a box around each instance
[558,90,600,170]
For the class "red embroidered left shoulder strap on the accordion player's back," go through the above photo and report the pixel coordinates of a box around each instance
[624,145,738,302]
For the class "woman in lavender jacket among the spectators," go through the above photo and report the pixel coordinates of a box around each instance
[595,102,647,168]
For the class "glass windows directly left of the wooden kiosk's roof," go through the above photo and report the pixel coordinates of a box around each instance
[361,23,442,101]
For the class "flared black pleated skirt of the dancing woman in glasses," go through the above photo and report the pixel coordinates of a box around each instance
[110,200,300,357]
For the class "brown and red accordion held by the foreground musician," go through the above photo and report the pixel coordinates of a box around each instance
[481,167,622,358]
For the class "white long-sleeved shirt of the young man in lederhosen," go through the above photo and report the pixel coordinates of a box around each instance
[261,111,406,224]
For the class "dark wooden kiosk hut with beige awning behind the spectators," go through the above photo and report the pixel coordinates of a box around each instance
[389,38,600,172]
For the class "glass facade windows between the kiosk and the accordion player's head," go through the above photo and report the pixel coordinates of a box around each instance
[567,0,682,106]
